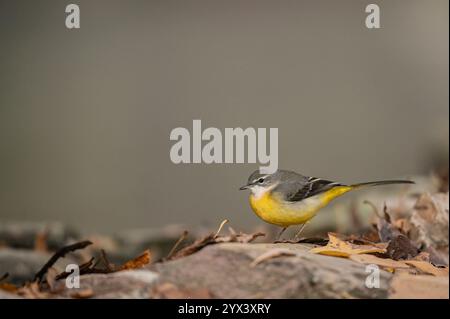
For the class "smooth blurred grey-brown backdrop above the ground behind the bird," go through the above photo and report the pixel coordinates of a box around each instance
[0,0,449,232]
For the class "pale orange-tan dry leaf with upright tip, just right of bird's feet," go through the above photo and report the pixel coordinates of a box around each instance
[310,233,386,258]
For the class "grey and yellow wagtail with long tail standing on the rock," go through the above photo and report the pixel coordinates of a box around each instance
[240,170,414,240]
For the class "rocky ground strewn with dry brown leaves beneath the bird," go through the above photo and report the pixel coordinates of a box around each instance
[0,175,449,298]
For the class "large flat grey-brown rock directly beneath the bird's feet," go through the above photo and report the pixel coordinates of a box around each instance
[151,243,392,298]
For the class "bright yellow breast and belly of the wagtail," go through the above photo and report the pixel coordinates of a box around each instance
[250,186,352,227]
